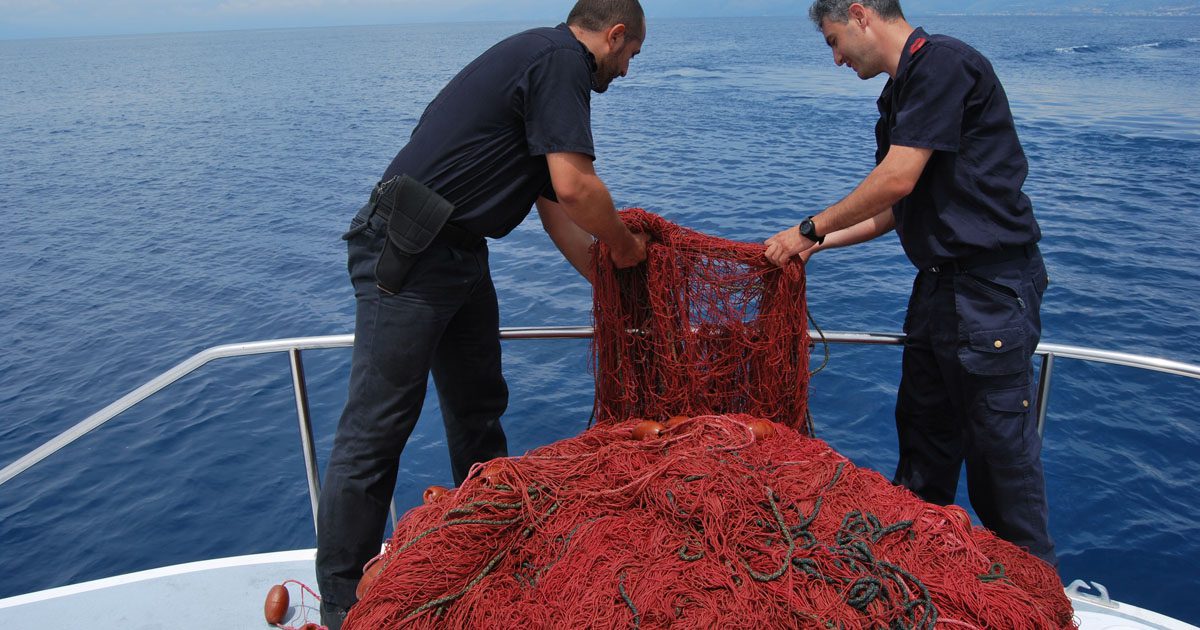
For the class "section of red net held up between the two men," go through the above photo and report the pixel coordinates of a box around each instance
[592,209,812,434]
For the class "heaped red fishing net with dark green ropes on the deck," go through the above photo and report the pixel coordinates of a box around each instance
[344,415,1073,630]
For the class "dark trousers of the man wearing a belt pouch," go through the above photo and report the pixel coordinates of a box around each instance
[317,206,509,608]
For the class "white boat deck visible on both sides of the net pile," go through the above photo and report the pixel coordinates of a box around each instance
[0,550,1200,630]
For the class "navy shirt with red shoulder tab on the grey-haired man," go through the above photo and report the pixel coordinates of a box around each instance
[875,29,1042,269]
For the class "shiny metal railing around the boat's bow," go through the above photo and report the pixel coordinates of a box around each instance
[0,326,1200,528]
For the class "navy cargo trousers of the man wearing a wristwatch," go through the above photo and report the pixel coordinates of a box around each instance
[894,247,1057,566]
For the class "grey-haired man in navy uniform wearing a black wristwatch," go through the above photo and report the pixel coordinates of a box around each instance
[766,0,1057,565]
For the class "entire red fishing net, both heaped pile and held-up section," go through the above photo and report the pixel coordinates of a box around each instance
[343,211,1074,630]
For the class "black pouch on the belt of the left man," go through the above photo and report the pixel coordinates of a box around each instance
[376,175,454,293]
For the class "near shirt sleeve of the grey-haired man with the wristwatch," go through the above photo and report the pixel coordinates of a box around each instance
[890,46,977,152]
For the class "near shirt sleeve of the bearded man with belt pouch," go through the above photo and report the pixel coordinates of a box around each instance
[523,48,595,160]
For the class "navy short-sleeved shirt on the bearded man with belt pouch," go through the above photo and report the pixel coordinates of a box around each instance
[383,24,595,238]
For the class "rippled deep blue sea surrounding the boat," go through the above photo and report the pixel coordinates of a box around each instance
[0,16,1200,623]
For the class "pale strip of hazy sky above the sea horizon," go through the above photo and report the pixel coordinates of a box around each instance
[0,0,1185,40]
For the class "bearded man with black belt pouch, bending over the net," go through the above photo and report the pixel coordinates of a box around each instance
[317,0,646,629]
